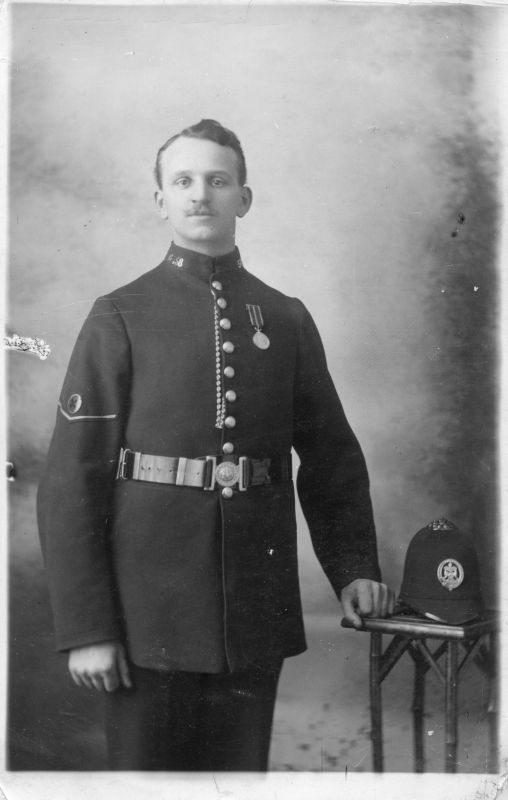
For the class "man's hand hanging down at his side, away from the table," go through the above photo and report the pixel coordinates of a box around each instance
[69,641,132,692]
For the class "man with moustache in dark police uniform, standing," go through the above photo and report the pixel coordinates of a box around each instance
[38,120,393,770]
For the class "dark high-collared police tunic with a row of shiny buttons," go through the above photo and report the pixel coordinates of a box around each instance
[38,244,380,673]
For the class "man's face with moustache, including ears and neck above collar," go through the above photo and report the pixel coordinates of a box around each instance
[155,136,252,256]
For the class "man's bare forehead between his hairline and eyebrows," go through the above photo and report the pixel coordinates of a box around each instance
[162,136,238,176]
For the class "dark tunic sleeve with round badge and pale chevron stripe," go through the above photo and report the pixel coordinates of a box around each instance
[37,298,130,650]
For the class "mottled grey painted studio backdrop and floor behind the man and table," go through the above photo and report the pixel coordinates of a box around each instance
[7,4,503,772]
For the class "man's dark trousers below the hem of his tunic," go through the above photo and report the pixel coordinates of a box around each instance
[104,664,282,772]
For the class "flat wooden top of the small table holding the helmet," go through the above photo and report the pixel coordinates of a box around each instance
[342,611,499,640]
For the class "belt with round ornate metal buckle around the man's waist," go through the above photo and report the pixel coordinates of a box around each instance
[116,447,292,492]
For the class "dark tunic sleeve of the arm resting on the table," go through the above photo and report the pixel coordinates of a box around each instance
[293,301,381,599]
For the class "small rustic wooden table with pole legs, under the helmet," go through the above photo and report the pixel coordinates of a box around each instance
[342,611,498,772]
